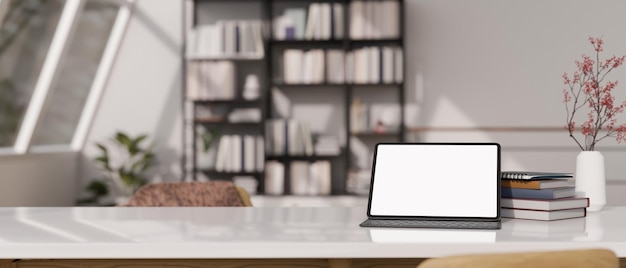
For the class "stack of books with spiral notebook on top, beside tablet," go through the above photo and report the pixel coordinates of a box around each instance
[500,171,589,221]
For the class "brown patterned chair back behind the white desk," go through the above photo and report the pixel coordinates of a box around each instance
[124,181,252,207]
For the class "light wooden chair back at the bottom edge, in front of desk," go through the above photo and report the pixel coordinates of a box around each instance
[417,249,619,268]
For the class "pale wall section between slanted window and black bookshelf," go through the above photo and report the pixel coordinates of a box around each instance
[79,0,182,197]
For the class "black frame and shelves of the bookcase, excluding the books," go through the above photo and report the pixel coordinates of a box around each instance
[183,0,406,195]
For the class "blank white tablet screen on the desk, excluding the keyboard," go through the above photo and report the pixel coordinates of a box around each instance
[370,144,500,218]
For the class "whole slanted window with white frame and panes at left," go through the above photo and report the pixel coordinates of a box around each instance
[0,0,130,153]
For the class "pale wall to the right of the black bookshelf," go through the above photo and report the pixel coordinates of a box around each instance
[405,0,626,199]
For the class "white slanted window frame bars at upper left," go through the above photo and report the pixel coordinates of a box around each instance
[0,0,135,155]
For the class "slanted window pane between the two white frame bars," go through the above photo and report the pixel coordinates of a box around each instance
[33,1,118,145]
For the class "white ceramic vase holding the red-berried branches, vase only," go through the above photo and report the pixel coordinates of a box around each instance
[574,151,606,211]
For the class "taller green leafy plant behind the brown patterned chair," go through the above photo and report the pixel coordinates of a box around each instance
[92,132,156,199]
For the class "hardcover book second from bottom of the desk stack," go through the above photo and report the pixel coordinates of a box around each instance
[500,197,589,210]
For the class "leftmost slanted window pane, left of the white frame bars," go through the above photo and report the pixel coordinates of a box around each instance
[0,0,64,147]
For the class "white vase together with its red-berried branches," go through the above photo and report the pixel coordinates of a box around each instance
[562,37,626,211]
